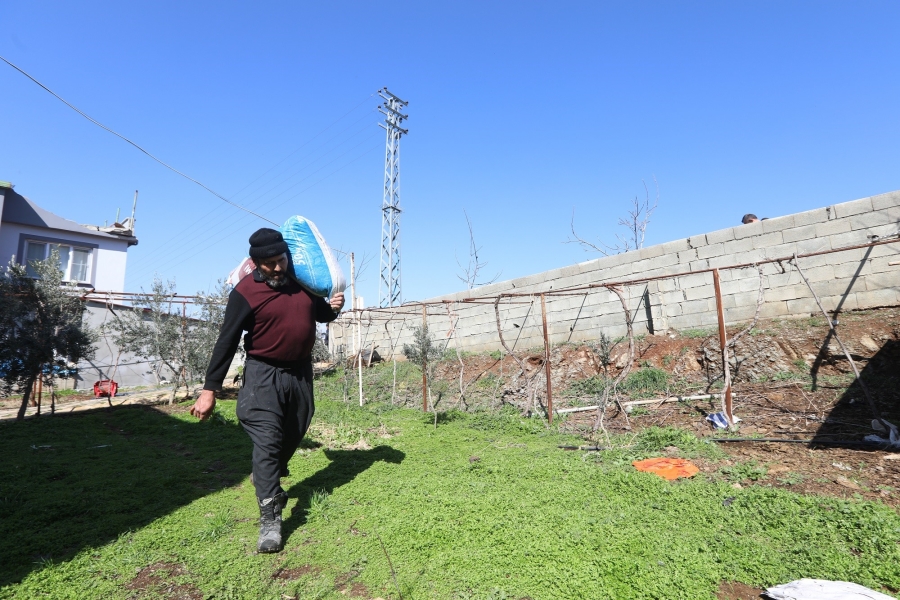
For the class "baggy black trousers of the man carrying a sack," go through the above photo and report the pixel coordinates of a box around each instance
[237,357,315,500]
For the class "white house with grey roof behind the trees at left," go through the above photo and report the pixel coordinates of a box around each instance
[0,181,157,388]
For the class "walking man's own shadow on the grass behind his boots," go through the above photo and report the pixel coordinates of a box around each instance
[284,446,406,537]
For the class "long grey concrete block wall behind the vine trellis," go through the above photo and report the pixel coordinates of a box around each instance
[329,191,900,357]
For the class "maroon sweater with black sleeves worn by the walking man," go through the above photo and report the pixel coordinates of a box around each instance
[203,270,337,391]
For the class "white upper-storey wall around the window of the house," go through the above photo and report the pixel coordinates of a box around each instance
[0,223,128,292]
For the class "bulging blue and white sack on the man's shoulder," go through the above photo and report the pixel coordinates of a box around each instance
[281,216,347,298]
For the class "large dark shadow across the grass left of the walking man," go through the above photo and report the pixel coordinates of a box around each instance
[0,405,250,584]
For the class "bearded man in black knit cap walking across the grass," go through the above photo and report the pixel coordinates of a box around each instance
[191,228,344,553]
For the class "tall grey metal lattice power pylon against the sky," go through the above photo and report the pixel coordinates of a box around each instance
[378,88,409,308]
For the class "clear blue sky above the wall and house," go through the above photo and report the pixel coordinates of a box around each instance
[0,0,900,305]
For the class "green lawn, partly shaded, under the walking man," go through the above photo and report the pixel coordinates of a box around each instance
[0,372,900,600]
